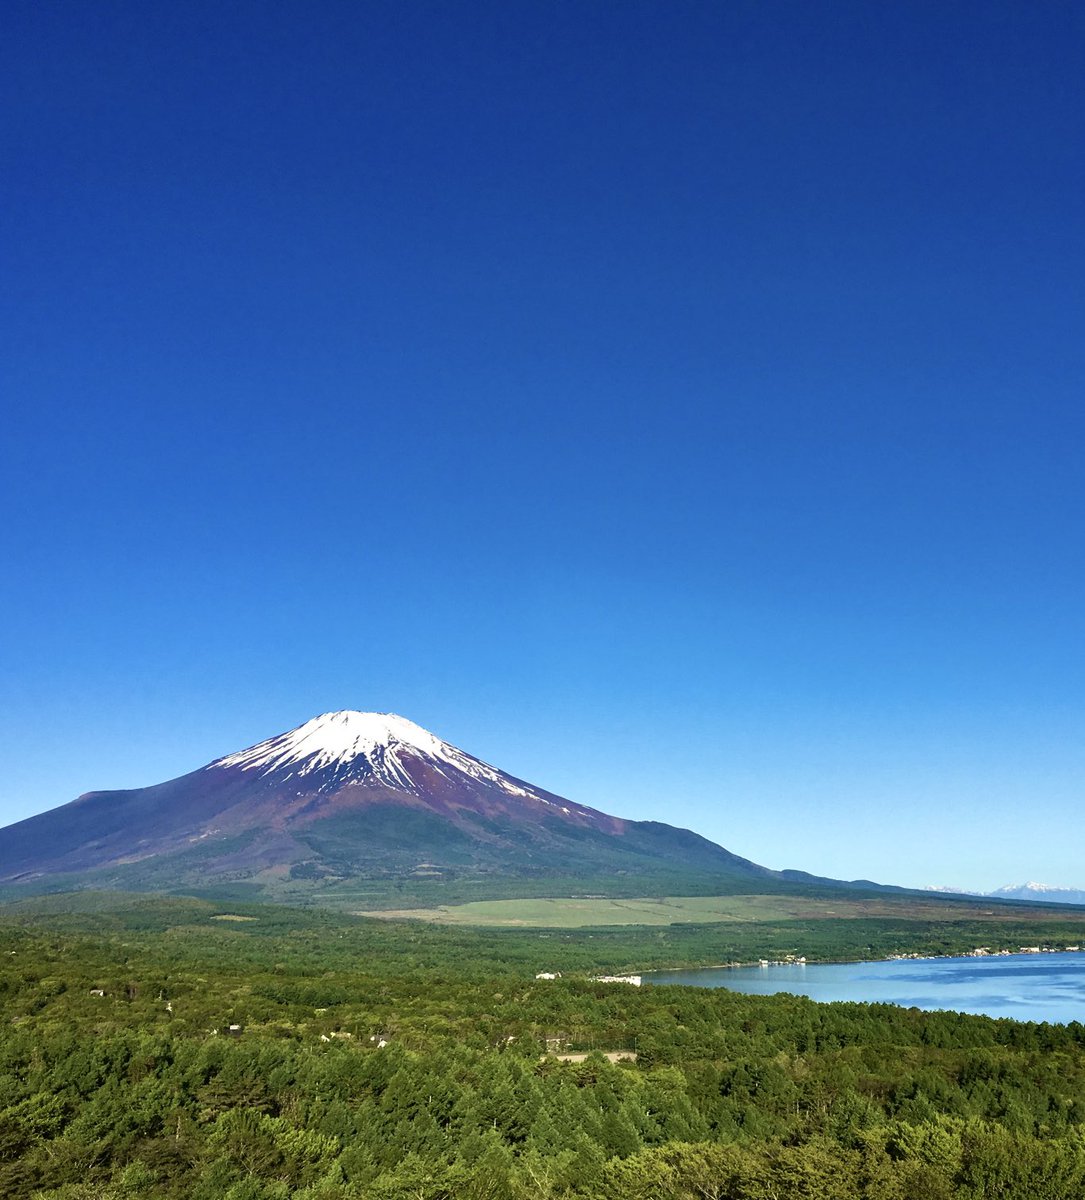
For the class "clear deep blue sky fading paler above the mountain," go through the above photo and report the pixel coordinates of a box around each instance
[0,0,1085,887]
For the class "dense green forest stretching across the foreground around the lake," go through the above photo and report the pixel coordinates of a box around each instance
[0,894,1085,1200]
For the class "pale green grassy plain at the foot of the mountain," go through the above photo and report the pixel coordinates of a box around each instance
[355,895,1085,938]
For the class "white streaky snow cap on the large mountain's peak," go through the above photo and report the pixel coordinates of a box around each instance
[206,709,564,808]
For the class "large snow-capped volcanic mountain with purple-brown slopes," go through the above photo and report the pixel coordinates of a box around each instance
[0,712,840,895]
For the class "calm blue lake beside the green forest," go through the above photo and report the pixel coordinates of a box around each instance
[643,953,1085,1022]
